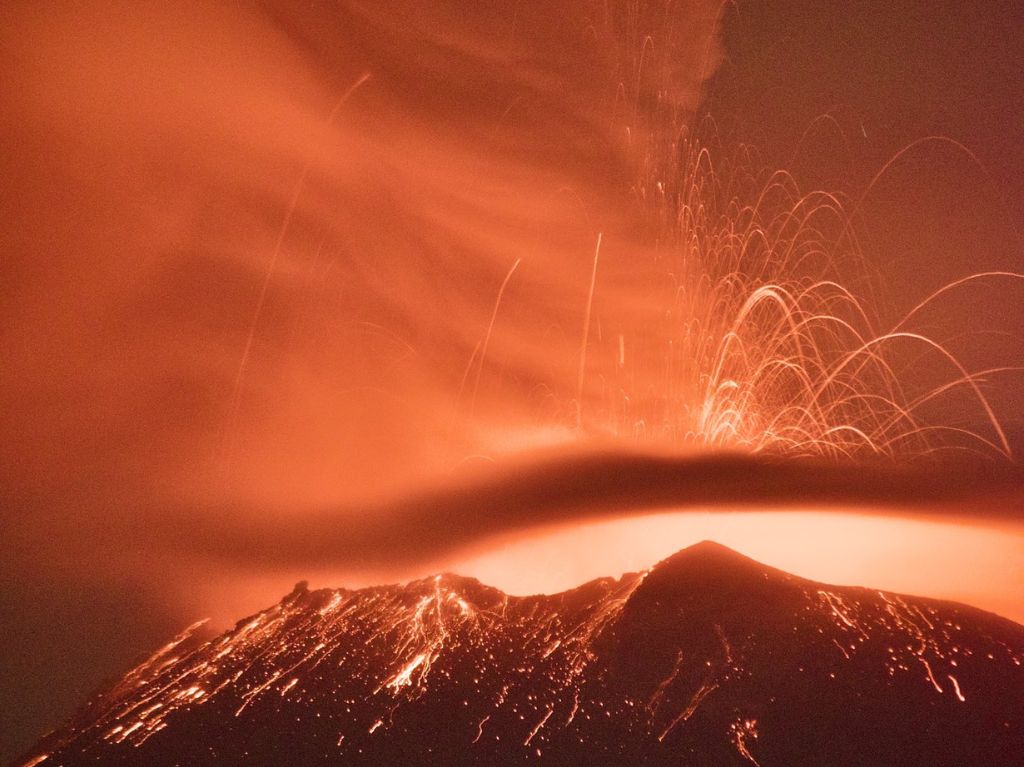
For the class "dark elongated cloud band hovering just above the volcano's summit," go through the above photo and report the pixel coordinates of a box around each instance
[138,453,1024,567]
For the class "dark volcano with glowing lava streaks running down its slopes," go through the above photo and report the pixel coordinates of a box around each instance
[20,542,1024,767]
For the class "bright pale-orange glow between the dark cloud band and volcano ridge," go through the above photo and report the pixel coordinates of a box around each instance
[192,509,1024,627]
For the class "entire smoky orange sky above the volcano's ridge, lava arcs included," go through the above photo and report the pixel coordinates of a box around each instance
[0,0,1024,760]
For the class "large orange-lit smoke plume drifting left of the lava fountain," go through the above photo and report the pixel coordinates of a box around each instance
[0,2,718,514]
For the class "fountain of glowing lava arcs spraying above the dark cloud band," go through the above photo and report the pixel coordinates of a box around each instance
[466,4,1024,459]
